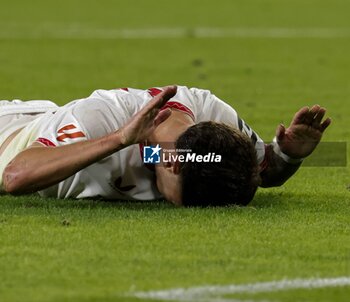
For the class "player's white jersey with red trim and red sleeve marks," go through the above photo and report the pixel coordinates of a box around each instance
[0,86,265,200]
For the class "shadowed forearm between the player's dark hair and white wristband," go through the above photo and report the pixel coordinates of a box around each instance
[260,144,301,188]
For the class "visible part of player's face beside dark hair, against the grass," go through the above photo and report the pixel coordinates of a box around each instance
[155,164,182,206]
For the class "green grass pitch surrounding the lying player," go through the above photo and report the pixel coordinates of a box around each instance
[0,0,350,302]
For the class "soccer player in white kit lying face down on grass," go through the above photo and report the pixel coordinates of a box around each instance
[0,86,330,206]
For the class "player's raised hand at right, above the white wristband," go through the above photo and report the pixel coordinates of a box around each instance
[276,105,331,158]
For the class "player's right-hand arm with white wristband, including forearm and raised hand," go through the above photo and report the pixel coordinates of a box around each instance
[260,105,331,187]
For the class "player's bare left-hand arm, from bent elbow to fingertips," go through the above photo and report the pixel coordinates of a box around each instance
[3,86,176,194]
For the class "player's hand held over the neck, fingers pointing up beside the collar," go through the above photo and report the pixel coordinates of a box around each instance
[118,86,177,146]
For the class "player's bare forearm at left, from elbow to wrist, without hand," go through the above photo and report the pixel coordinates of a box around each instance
[3,132,125,194]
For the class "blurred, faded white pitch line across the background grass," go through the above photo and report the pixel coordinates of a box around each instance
[0,27,350,40]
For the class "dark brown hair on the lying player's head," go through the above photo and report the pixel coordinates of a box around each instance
[175,122,259,207]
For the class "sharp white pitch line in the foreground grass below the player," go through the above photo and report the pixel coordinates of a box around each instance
[131,276,350,302]
